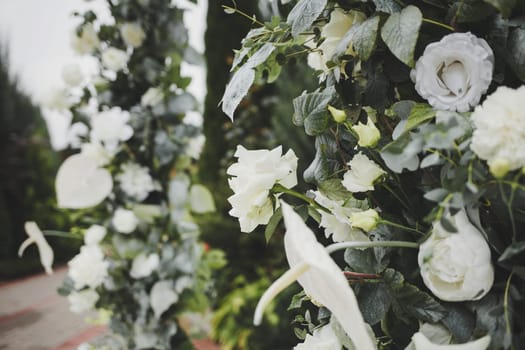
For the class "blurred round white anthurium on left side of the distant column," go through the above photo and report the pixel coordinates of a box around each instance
[55,153,113,209]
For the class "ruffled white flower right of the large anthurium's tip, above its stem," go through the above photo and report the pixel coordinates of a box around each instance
[314,191,369,242]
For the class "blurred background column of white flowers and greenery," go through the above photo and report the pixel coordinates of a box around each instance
[21,0,224,349]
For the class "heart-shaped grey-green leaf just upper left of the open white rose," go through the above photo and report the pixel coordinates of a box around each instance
[381,6,423,67]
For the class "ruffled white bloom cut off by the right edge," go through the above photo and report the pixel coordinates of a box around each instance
[470,86,525,175]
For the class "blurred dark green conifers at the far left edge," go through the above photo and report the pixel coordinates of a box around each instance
[0,45,73,279]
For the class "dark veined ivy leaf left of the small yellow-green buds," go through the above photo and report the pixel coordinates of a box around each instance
[293,87,335,136]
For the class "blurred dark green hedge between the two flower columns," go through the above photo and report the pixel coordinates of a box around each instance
[199,0,317,350]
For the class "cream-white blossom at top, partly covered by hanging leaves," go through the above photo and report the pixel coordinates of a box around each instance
[308,7,366,71]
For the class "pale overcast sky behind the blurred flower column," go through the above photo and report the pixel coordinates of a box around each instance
[0,0,207,147]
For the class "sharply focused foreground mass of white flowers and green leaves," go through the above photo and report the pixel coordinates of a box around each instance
[222,0,525,350]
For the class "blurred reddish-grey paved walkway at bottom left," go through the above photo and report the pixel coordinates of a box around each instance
[0,268,219,350]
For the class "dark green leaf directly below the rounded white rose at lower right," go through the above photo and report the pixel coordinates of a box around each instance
[392,283,447,323]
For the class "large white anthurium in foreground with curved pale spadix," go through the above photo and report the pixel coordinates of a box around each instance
[254,201,377,350]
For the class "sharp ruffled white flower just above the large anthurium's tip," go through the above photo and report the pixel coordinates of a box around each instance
[226,145,297,232]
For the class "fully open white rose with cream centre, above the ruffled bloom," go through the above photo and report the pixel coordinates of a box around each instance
[410,33,494,112]
